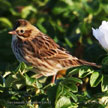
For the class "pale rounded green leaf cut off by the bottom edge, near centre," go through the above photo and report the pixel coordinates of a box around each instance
[55,96,71,108]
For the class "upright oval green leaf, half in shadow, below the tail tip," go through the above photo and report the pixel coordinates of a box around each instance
[90,72,102,87]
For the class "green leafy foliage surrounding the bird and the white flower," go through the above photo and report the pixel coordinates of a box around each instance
[0,0,108,108]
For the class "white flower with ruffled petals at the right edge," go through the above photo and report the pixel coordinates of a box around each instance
[92,21,108,50]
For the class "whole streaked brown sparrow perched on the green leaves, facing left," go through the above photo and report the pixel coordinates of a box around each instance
[8,19,99,83]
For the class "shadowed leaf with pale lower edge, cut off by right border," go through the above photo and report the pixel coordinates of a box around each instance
[101,75,108,92]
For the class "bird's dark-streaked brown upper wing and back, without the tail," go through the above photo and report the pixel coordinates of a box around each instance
[23,35,72,59]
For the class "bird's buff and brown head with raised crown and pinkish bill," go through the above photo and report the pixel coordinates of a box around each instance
[8,19,39,39]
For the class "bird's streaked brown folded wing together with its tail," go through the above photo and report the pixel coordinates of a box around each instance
[21,35,98,67]
